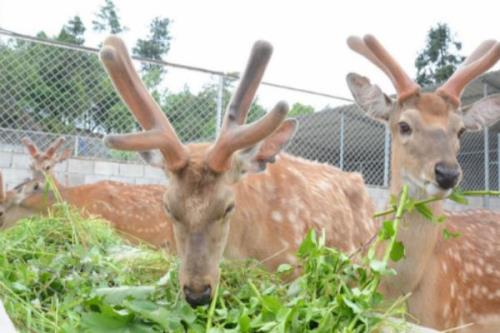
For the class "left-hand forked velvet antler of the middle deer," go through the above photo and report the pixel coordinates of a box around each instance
[100,36,188,171]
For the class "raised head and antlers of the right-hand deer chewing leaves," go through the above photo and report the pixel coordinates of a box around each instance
[347,35,500,196]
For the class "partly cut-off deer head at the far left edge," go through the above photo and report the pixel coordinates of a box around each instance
[0,172,43,229]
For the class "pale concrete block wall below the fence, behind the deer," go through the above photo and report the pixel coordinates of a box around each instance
[0,151,500,211]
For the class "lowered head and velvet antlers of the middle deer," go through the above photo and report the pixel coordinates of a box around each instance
[100,36,296,306]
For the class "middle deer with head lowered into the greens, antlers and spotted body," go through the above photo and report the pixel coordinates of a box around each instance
[100,36,376,306]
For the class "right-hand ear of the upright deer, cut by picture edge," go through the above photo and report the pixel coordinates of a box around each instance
[463,94,500,131]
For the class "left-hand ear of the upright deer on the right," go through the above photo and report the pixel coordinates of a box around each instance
[346,73,393,122]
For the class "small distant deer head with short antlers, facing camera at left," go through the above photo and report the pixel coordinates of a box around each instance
[21,137,72,179]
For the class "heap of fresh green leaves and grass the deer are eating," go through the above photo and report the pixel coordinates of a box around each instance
[0,200,403,333]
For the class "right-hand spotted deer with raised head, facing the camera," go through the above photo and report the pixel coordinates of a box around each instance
[347,35,500,332]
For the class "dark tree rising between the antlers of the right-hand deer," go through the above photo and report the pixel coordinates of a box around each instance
[415,23,465,86]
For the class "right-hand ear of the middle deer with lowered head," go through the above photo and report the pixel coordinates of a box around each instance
[238,119,298,173]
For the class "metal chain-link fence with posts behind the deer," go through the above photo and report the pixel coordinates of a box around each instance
[0,31,500,189]
